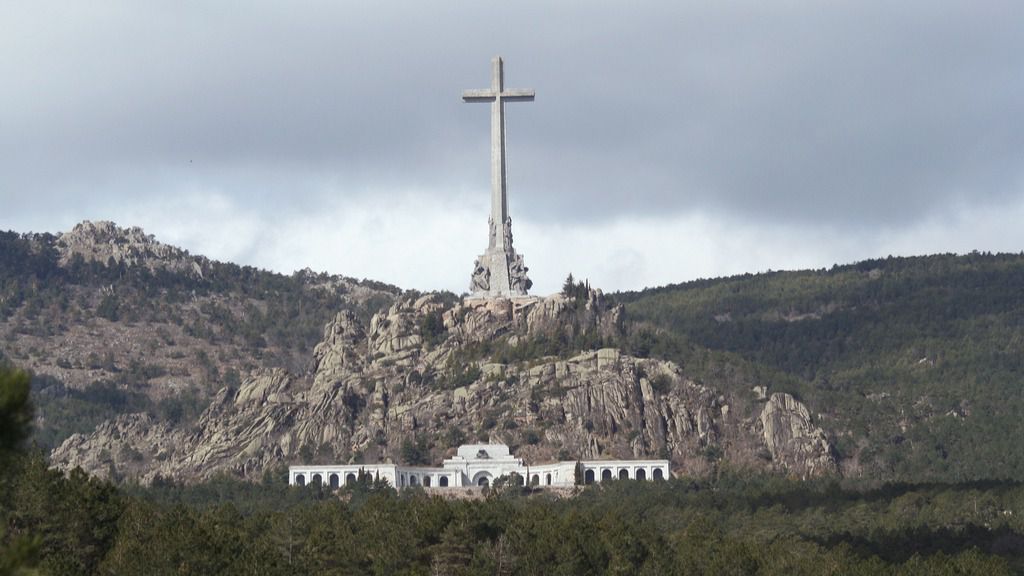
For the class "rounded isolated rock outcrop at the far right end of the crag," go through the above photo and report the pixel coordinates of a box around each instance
[761,394,837,477]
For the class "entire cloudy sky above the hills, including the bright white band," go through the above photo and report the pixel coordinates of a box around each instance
[0,0,1024,293]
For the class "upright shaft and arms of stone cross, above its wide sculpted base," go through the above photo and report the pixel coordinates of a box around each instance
[462,56,535,248]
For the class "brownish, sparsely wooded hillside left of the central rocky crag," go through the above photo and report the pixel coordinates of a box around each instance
[0,222,400,449]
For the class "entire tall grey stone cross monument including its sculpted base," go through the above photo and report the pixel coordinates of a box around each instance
[462,56,534,298]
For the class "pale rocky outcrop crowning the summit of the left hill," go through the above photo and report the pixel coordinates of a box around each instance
[56,220,203,278]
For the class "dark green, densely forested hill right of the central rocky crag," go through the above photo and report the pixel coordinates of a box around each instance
[615,253,1024,481]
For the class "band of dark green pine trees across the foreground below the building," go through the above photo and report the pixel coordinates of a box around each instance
[3,458,1024,575]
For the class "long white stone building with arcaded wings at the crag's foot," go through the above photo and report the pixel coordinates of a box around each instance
[288,444,670,490]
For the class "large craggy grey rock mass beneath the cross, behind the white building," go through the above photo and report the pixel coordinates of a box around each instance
[53,290,835,482]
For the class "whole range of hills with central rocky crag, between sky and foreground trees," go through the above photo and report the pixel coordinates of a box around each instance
[0,222,1024,482]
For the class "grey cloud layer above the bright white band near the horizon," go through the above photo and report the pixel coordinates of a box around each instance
[0,2,1024,236]
